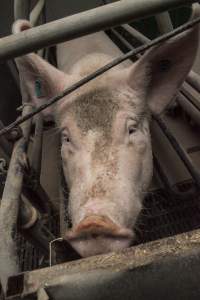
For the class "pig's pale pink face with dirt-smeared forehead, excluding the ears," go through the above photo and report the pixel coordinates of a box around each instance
[55,86,152,256]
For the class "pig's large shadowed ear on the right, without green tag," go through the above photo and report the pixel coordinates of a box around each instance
[128,26,198,114]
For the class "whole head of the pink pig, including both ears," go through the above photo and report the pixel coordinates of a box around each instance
[13,19,198,256]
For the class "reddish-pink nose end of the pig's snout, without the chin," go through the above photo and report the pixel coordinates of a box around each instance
[65,215,133,241]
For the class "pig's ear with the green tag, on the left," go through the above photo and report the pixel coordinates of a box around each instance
[13,20,66,119]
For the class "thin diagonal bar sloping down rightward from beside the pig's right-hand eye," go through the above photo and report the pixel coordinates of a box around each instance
[153,115,200,188]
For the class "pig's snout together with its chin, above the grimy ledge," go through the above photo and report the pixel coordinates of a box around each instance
[65,216,133,256]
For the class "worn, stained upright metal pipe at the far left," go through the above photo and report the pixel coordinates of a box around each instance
[0,104,33,289]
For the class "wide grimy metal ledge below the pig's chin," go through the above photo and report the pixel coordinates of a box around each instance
[6,230,200,300]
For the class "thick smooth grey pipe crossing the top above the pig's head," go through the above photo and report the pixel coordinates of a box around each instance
[0,0,197,60]
